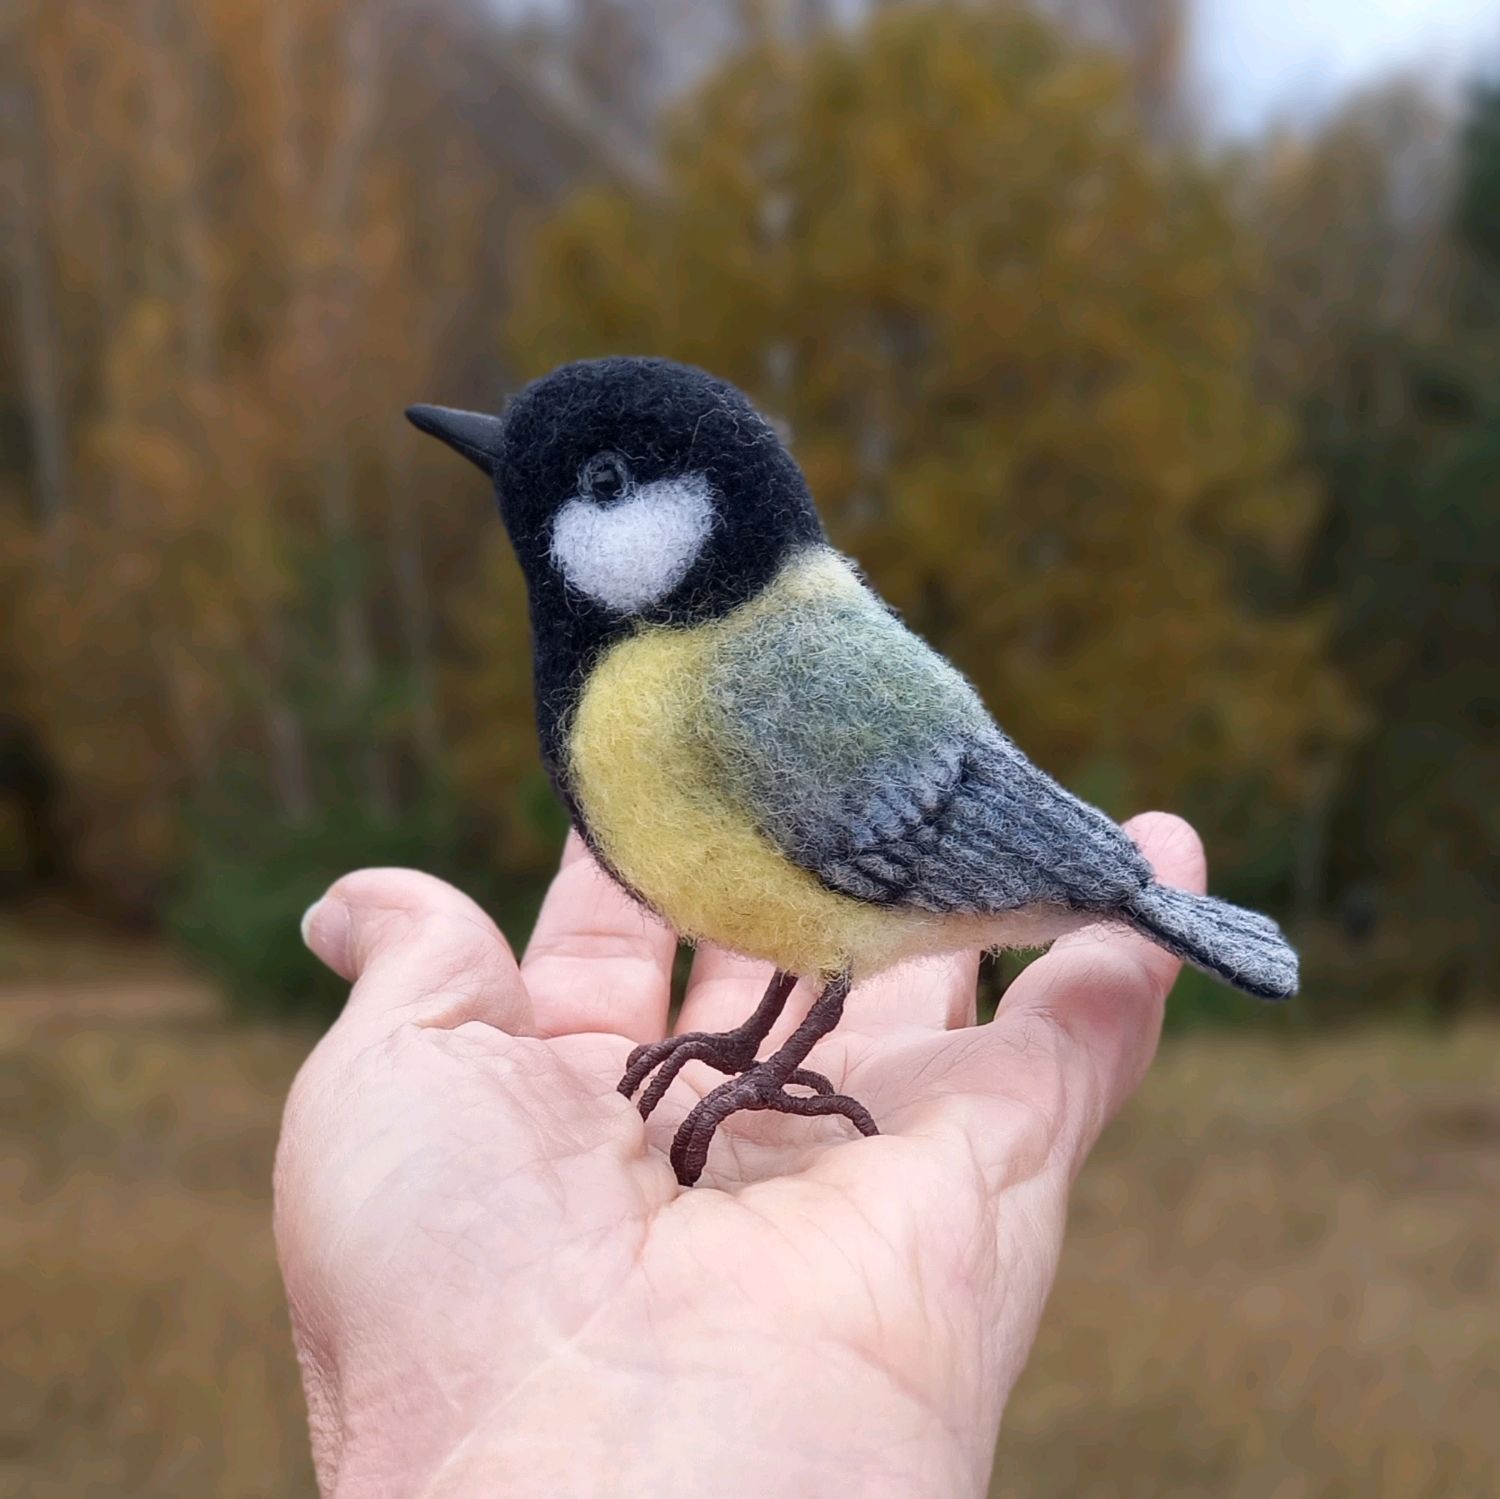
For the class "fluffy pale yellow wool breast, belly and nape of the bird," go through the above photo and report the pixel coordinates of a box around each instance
[569,548,1092,975]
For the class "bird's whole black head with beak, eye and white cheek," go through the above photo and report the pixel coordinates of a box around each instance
[407,359,824,623]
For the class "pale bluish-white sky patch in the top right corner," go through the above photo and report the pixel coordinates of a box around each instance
[1194,0,1500,134]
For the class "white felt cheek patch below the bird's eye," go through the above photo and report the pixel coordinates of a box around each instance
[552,474,714,614]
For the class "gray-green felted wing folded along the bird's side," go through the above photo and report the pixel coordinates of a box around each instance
[707,561,1151,912]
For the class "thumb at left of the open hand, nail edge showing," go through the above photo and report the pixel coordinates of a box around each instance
[302,869,531,1032]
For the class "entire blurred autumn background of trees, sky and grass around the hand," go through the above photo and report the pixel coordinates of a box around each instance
[0,0,1500,1499]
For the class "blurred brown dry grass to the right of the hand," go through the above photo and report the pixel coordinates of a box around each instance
[993,1025,1500,1499]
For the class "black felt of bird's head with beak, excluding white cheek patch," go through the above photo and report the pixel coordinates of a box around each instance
[408,357,824,623]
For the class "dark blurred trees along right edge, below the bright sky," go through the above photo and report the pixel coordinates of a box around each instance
[1260,83,1500,1008]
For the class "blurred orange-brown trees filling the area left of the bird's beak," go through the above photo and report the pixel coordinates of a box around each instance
[0,0,663,912]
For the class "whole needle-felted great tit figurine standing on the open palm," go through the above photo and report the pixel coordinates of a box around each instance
[407,357,1298,1185]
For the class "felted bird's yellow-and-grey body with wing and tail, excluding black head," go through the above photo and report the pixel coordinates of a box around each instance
[570,546,1287,993]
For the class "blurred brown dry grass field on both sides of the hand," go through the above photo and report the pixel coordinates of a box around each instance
[0,932,1500,1499]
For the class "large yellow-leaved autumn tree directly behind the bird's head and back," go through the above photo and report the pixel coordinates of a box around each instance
[482,5,1347,900]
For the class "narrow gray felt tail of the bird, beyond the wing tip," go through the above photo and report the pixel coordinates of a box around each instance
[1121,885,1298,999]
